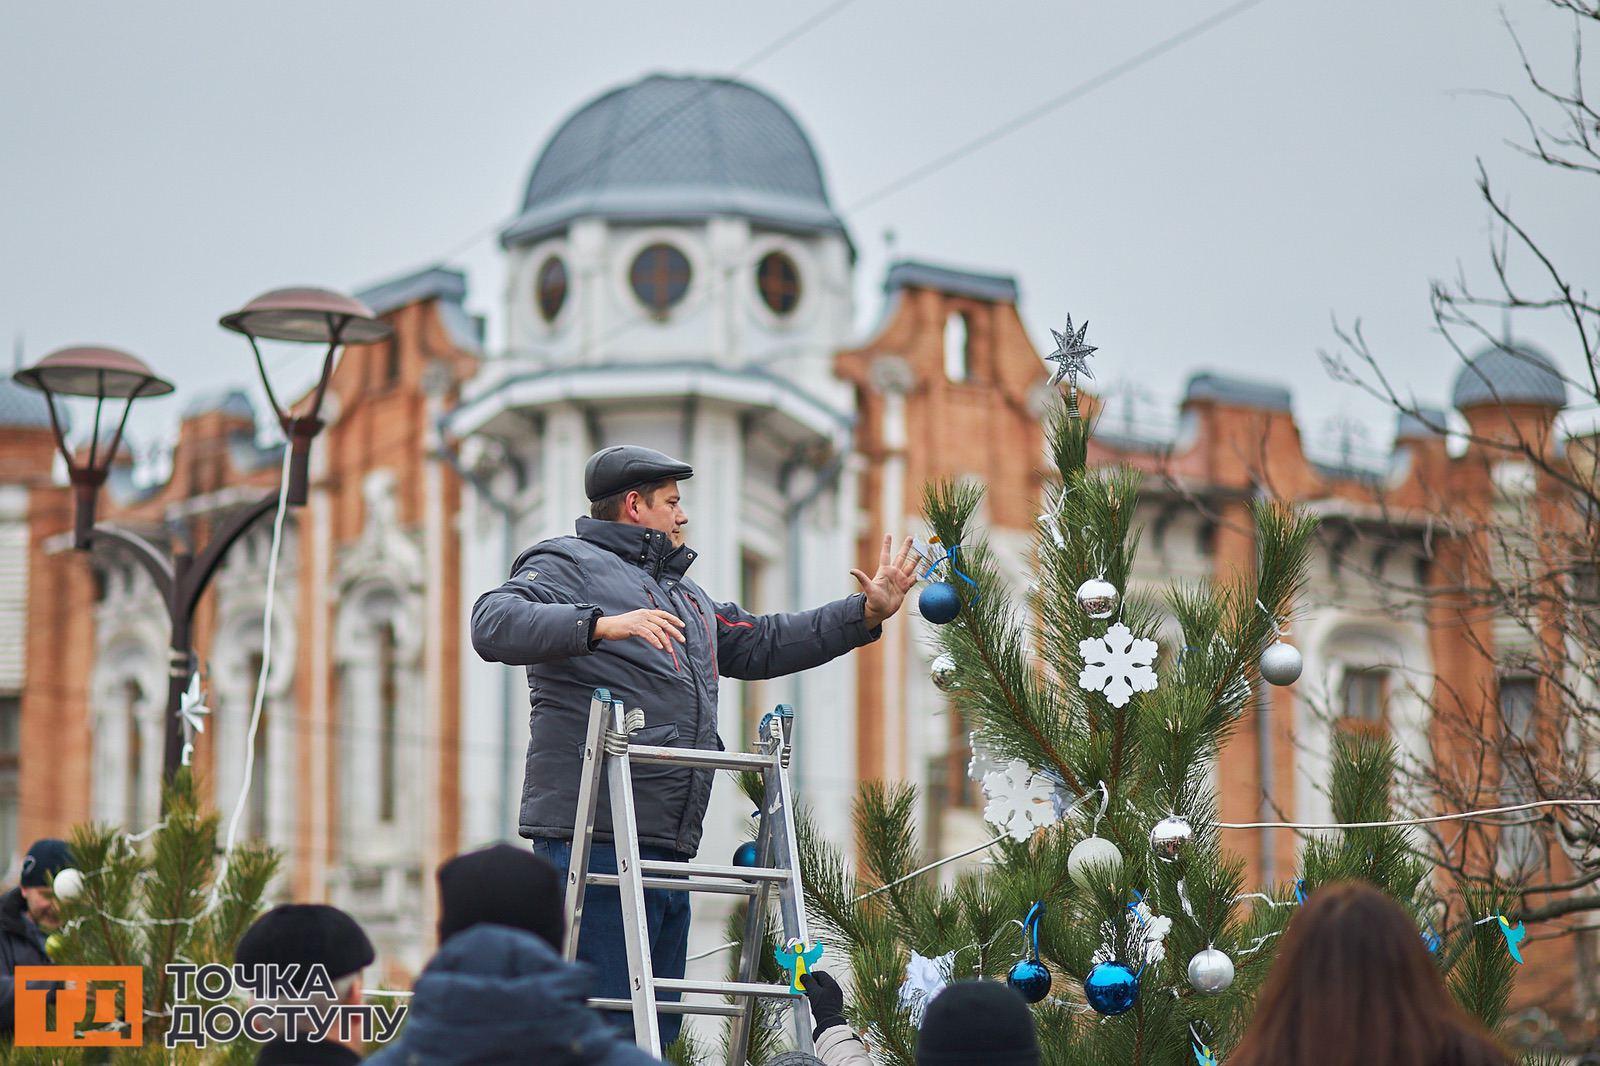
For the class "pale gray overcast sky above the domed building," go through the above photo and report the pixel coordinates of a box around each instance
[0,0,1600,464]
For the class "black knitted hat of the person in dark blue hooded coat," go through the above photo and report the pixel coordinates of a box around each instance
[438,844,563,951]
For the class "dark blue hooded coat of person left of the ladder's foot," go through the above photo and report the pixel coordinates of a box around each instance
[368,925,656,1066]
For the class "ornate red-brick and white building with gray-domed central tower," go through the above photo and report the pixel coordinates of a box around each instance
[0,77,1595,1030]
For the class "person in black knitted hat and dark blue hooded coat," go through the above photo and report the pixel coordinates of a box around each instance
[366,844,658,1066]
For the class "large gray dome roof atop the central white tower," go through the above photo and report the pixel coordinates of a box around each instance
[501,74,845,245]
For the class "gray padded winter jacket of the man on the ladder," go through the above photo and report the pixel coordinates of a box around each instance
[472,519,882,855]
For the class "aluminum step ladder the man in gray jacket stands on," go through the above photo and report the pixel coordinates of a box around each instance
[562,688,811,1066]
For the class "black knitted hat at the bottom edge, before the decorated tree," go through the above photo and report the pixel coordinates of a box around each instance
[917,981,1038,1066]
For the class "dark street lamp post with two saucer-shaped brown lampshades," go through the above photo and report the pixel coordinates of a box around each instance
[13,288,390,781]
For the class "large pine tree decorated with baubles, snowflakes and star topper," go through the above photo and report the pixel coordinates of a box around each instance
[802,392,1515,1066]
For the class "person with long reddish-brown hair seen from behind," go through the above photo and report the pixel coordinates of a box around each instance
[1227,882,1512,1066]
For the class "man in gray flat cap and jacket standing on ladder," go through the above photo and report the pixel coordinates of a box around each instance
[472,445,917,1045]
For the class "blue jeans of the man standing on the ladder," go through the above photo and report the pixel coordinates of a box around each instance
[533,837,690,1048]
